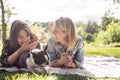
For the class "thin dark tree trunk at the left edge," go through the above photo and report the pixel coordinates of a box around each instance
[0,0,6,42]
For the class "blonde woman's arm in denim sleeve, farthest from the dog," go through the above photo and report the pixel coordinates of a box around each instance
[65,38,84,68]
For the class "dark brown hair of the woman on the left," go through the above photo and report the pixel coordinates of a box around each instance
[10,20,32,50]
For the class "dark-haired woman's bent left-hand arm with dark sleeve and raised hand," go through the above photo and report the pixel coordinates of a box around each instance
[0,41,34,67]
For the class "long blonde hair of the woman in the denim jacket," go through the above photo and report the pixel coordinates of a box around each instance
[55,17,77,51]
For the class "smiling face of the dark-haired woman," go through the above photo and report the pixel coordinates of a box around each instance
[17,30,30,45]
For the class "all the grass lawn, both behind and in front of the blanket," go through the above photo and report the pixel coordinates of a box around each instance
[0,47,120,80]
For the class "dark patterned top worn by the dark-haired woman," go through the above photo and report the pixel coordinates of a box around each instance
[0,39,41,67]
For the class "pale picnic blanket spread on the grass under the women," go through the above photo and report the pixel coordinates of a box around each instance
[0,56,120,78]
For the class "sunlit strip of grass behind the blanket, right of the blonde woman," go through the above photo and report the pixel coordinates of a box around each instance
[85,47,120,59]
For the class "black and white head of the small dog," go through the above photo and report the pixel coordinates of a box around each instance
[30,46,49,66]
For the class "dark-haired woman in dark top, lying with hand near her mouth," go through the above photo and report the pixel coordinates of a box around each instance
[0,20,40,67]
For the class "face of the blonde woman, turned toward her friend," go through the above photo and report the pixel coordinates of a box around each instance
[53,27,67,42]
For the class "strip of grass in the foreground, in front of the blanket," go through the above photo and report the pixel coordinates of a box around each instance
[0,71,118,80]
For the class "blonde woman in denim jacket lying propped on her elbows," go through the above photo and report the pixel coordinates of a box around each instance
[47,17,84,68]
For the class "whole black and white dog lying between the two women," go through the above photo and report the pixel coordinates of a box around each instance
[19,46,49,68]
